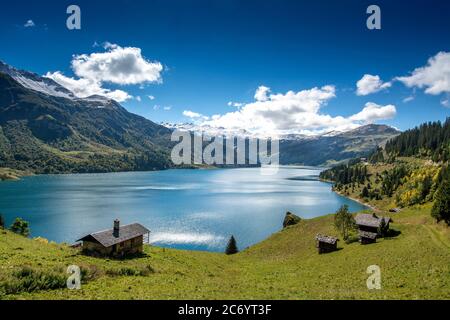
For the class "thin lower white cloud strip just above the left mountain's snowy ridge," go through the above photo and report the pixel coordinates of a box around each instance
[45,71,132,102]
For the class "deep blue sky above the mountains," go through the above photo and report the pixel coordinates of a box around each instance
[0,0,450,131]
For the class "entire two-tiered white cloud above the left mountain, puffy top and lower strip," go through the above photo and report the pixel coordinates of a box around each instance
[45,42,163,102]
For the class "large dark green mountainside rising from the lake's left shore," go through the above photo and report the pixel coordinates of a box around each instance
[0,72,172,173]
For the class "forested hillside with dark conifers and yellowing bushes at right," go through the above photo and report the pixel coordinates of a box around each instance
[321,118,450,224]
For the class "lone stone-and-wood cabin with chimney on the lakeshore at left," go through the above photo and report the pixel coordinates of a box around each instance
[77,220,150,257]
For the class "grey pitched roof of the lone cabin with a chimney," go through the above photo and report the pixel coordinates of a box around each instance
[77,223,150,248]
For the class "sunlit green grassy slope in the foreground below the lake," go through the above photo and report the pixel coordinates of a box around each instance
[0,201,450,299]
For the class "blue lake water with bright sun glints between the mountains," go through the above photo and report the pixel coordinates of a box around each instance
[0,167,364,251]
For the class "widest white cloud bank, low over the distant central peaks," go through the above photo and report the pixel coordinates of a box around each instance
[183,85,396,137]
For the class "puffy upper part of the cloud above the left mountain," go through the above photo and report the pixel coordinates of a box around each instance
[72,43,163,85]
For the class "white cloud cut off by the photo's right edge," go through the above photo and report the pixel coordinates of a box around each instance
[396,52,450,95]
